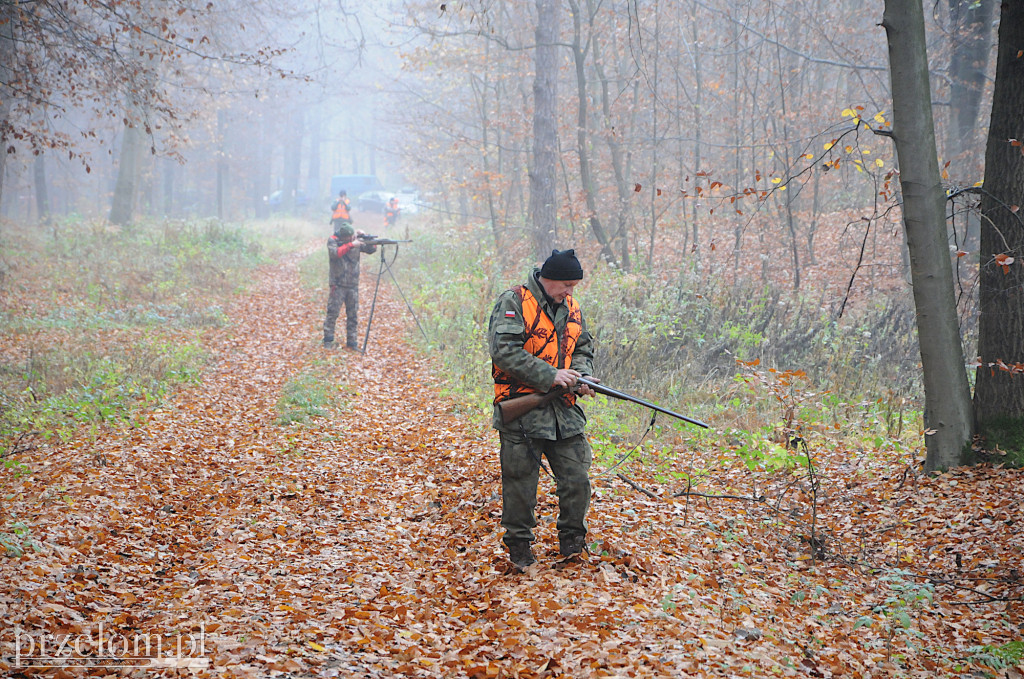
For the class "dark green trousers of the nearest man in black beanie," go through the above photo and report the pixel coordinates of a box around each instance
[499,431,591,545]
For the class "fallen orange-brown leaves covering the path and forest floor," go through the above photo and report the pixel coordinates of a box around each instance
[0,241,1024,677]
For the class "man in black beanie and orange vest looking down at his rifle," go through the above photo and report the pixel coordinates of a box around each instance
[487,250,594,571]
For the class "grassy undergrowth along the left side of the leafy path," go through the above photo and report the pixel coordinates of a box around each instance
[0,217,313,456]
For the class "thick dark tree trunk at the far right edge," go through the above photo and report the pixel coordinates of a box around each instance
[974,0,1024,454]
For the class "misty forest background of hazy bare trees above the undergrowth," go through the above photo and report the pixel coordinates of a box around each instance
[2,0,992,266]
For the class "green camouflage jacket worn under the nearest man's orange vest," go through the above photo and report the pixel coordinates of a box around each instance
[487,267,594,440]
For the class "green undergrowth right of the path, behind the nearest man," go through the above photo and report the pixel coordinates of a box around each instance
[385,228,921,456]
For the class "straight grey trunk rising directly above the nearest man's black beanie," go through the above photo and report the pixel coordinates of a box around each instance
[529,0,558,259]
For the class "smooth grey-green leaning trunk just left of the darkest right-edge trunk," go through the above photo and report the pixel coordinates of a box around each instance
[882,0,973,471]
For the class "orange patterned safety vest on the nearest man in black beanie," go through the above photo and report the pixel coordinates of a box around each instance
[490,286,583,406]
